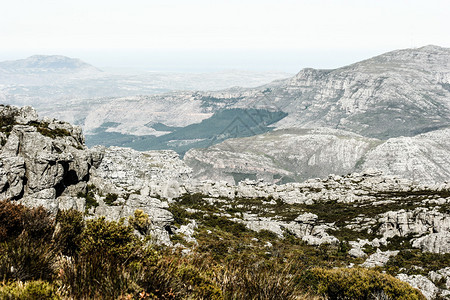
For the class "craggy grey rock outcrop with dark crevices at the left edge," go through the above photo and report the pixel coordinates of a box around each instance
[0,106,101,210]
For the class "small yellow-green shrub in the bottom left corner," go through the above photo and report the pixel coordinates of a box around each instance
[0,280,61,300]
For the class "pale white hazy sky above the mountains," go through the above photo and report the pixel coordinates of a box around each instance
[0,0,450,72]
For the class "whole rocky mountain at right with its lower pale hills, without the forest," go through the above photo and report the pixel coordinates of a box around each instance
[185,46,450,183]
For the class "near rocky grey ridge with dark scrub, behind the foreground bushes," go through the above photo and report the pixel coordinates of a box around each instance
[0,106,450,299]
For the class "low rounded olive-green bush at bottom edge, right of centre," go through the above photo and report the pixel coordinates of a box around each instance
[301,268,425,300]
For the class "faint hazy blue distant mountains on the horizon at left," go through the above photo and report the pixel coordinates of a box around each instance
[0,55,291,106]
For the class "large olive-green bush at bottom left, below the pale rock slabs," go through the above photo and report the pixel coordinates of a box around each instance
[60,217,157,299]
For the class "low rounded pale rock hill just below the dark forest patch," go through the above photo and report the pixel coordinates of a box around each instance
[184,128,379,183]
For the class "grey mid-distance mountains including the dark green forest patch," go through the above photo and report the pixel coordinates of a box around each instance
[2,46,450,183]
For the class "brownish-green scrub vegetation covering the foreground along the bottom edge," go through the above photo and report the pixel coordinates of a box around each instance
[0,198,424,299]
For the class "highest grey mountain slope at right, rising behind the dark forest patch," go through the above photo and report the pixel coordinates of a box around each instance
[234,46,450,139]
